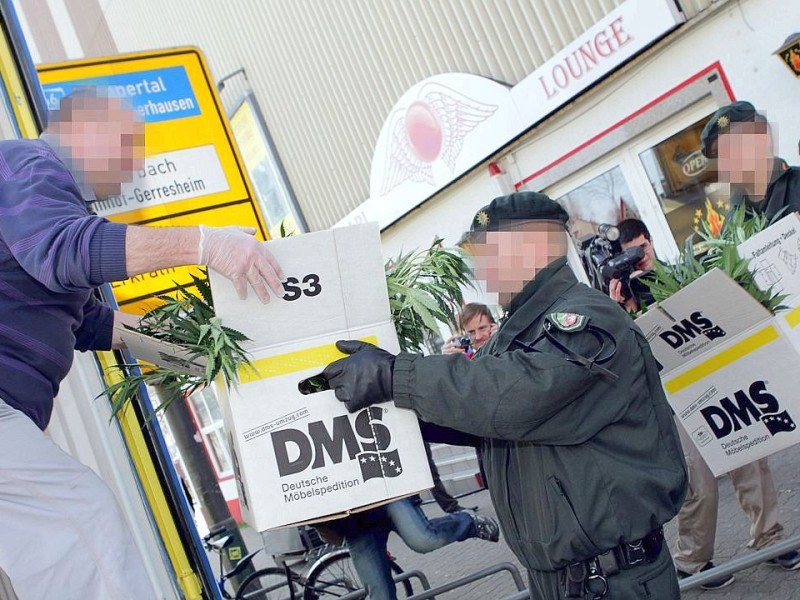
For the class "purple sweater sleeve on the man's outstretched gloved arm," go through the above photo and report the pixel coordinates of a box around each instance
[0,143,127,292]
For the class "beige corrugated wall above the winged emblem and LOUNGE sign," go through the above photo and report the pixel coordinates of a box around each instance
[92,0,632,229]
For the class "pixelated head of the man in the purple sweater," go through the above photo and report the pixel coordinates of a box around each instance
[55,98,144,198]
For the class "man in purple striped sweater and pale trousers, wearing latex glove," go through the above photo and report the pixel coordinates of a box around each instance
[0,89,283,600]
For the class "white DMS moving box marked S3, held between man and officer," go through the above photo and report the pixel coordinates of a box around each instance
[206,223,432,531]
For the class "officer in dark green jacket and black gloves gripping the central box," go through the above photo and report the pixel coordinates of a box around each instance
[324,192,687,600]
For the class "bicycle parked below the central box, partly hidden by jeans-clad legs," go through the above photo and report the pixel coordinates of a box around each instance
[235,526,414,600]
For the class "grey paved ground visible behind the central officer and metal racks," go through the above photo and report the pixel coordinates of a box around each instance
[239,445,800,600]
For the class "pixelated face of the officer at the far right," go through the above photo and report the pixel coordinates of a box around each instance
[717,123,774,189]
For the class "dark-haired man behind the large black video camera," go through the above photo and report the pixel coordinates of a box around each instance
[608,219,657,313]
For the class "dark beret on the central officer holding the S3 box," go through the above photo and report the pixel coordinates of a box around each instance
[470,192,569,233]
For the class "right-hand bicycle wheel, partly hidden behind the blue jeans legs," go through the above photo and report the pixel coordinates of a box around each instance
[303,548,414,600]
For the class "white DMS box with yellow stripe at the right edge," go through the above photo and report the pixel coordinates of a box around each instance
[636,270,800,475]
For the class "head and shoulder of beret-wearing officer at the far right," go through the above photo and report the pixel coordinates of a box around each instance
[700,101,800,219]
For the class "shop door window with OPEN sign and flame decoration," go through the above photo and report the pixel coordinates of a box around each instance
[639,115,729,246]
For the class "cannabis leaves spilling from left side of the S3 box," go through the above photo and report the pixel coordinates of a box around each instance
[105,276,249,415]
